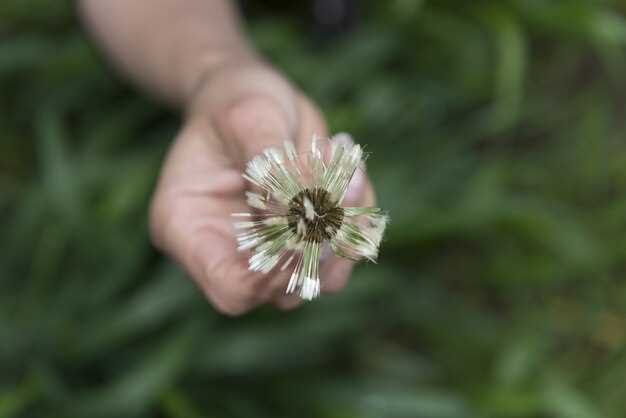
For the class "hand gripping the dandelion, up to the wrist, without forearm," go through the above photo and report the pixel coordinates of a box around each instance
[150,59,374,315]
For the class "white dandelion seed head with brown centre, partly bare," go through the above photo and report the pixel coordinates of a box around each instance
[233,134,388,300]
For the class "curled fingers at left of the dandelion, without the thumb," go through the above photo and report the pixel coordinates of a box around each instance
[150,122,269,315]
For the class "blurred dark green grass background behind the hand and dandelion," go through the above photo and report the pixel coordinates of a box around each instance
[0,0,626,418]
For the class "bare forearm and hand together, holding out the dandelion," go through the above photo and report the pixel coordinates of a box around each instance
[80,0,375,315]
